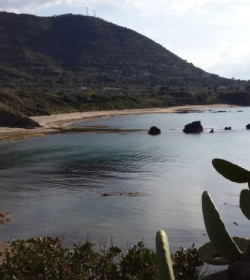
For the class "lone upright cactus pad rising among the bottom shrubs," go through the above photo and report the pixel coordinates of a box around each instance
[156,229,175,280]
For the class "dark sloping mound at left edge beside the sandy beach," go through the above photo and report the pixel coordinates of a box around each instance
[0,110,40,129]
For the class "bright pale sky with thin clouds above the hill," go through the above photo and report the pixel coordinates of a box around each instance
[0,0,250,80]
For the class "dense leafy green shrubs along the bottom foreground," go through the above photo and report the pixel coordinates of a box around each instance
[0,237,203,280]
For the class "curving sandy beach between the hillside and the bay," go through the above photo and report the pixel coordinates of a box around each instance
[0,104,240,141]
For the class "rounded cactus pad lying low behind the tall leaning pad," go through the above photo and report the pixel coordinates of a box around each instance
[198,236,249,265]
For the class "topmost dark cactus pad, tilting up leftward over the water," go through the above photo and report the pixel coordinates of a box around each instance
[212,158,250,183]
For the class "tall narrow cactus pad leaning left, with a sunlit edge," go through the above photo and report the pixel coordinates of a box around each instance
[202,191,242,263]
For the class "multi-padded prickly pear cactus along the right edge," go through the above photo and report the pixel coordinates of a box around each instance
[199,159,250,280]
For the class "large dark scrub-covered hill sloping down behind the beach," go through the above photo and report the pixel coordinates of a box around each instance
[0,12,248,124]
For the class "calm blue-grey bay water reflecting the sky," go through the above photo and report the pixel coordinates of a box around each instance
[0,108,250,250]
